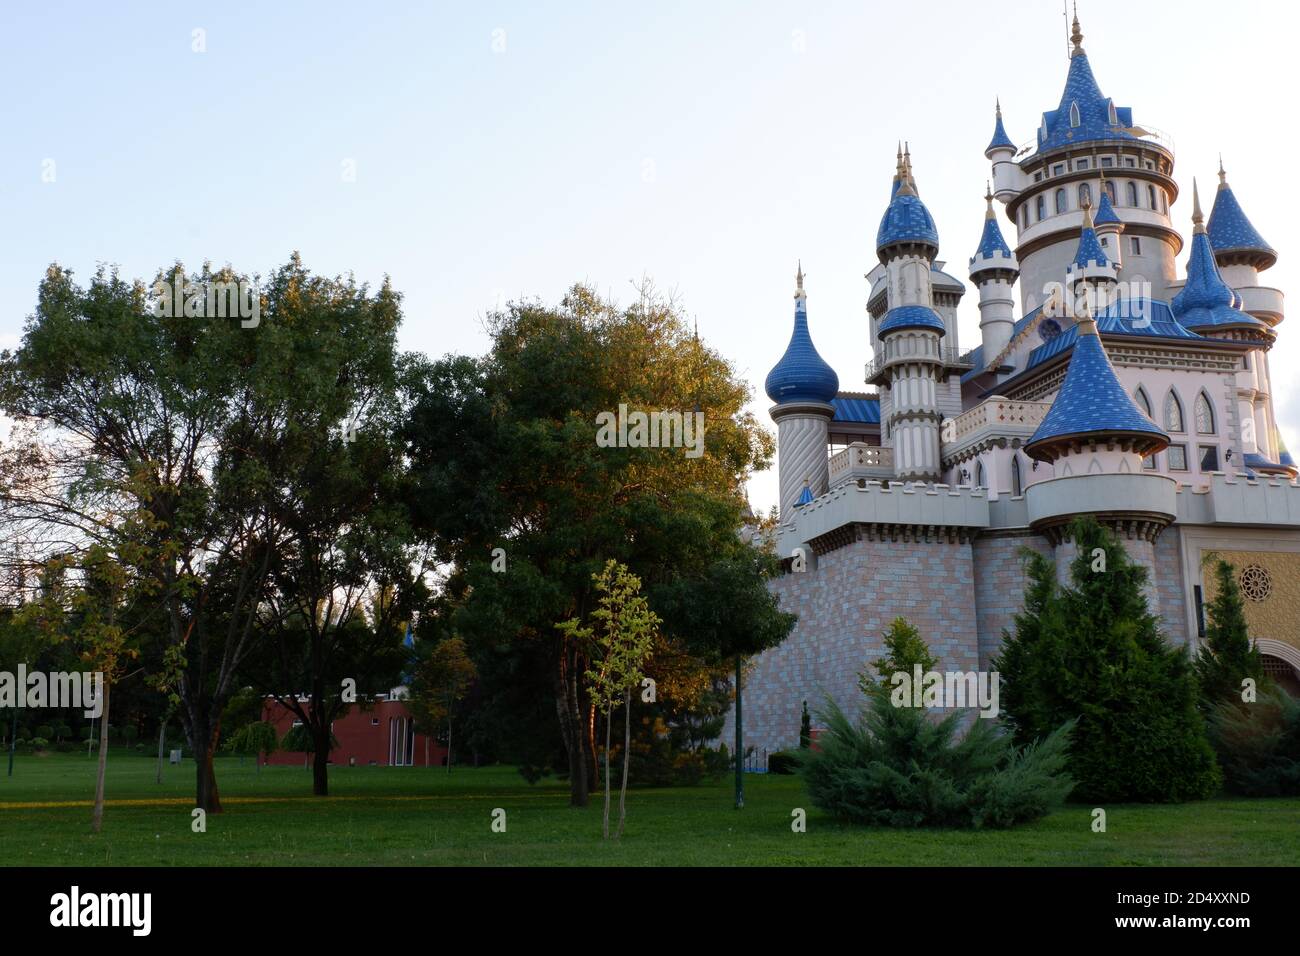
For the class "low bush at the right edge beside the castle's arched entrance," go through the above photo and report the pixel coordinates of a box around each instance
[1209,687,1300,796]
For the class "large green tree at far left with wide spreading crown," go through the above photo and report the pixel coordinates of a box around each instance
[0,254,400,813]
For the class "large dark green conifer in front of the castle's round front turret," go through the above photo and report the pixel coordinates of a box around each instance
[995,518,1221,803]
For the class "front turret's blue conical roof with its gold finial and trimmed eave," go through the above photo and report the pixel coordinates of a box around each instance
[1024,316,1169,462]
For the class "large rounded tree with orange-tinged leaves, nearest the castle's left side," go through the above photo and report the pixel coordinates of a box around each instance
[408,286,789,806]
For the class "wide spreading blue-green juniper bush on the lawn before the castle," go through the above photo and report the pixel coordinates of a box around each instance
[793,687,1074,829]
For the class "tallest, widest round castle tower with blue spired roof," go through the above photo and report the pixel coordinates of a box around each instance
[987,17,1183,313]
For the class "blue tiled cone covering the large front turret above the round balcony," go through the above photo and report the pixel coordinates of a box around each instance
[1026,328,1169,457]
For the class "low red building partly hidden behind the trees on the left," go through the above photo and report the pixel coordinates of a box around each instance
[261,696,447,767]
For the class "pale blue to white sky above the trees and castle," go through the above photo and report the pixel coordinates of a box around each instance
[0,0,1300,510]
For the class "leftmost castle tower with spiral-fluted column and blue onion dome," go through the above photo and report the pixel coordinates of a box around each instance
[764,264,840,520]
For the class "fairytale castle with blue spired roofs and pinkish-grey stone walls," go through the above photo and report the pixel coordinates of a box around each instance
[723,7,1300,752]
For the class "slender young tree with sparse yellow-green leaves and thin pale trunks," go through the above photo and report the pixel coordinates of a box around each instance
[556,559,660,839]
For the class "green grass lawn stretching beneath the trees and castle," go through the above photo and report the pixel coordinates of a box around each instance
[0,753,1300,866]
